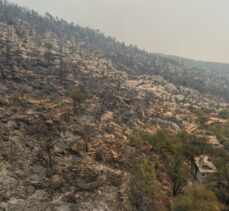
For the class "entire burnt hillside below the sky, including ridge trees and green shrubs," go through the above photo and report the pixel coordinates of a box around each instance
[0,0,229,211]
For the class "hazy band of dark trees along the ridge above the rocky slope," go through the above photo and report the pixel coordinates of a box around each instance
[0,0,229,100]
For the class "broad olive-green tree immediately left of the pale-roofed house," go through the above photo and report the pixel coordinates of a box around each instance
[131,130,200,196]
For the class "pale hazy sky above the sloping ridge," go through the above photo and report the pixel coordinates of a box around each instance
[10,0,229,63]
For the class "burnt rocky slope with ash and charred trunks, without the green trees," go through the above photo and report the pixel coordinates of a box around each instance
[0,2,228,210]
